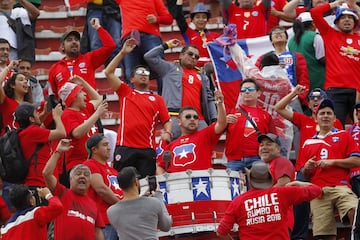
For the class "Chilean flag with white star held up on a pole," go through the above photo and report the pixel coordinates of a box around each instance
[207,33,274,110]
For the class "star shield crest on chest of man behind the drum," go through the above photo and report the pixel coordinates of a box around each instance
[173,143,196,167]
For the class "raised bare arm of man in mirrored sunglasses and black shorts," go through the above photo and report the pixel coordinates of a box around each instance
[105,38,136,91]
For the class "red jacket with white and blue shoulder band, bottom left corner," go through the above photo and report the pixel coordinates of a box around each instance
[1,197,62,240]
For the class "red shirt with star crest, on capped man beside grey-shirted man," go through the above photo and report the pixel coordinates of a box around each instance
[84,159,123,224]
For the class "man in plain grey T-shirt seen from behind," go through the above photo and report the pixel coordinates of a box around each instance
[107,167,172,239]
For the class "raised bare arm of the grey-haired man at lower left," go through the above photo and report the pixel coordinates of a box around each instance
[42,139,73,192]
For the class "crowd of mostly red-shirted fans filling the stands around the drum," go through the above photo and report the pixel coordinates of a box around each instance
[0,0,360,240]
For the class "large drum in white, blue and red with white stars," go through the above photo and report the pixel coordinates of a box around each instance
[140,169,246,237]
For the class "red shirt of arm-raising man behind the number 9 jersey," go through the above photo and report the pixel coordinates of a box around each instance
[292,112,343,171]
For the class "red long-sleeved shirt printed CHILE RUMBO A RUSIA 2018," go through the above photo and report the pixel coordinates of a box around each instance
[217,185,321,240]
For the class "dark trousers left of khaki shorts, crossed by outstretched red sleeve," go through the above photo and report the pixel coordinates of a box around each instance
[291,171,310,240]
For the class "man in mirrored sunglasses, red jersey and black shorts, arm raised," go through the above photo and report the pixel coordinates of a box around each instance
[105,38,171,177]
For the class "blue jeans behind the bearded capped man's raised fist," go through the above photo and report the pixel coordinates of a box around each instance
[87,9,122,65]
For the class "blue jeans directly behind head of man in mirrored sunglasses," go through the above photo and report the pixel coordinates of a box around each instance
[124,32,164,95]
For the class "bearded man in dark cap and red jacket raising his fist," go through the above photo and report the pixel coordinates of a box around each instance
[48,18,116,97]
